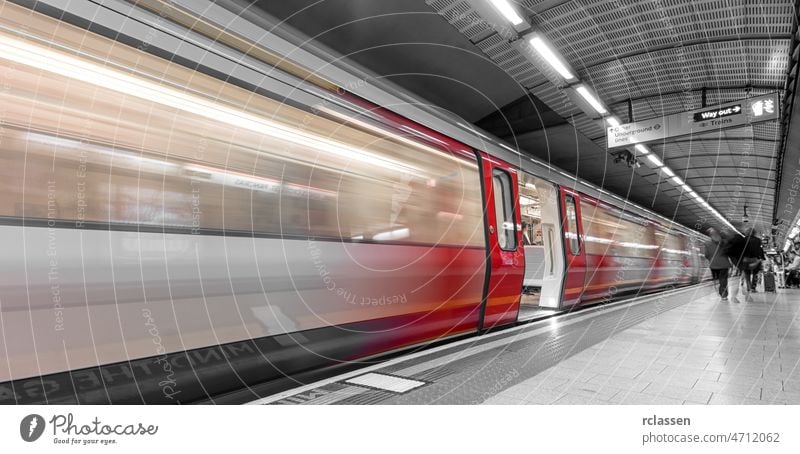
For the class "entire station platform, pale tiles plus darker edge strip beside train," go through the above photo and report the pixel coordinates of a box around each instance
[253,284,800,405]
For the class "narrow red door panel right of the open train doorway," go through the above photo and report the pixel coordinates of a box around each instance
[561,187,586,306]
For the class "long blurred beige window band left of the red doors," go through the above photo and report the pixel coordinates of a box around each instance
[0,34,484,247]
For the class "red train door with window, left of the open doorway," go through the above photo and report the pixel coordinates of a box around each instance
[480,153,525,329]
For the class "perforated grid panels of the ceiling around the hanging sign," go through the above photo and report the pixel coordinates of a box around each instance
[427,0,793,231]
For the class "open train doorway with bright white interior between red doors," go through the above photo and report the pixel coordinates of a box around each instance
[519,172,564,320]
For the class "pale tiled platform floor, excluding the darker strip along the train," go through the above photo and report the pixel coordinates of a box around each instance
[484,289,800,405]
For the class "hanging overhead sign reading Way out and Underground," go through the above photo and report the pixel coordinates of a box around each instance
[607,93,778,148]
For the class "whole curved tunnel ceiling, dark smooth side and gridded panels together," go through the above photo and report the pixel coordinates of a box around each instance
[255,0,795,232]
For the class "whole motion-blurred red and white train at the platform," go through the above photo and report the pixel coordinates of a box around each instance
[0,2,706,403]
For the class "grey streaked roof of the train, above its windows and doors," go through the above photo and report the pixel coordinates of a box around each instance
[41,0,706,238]
